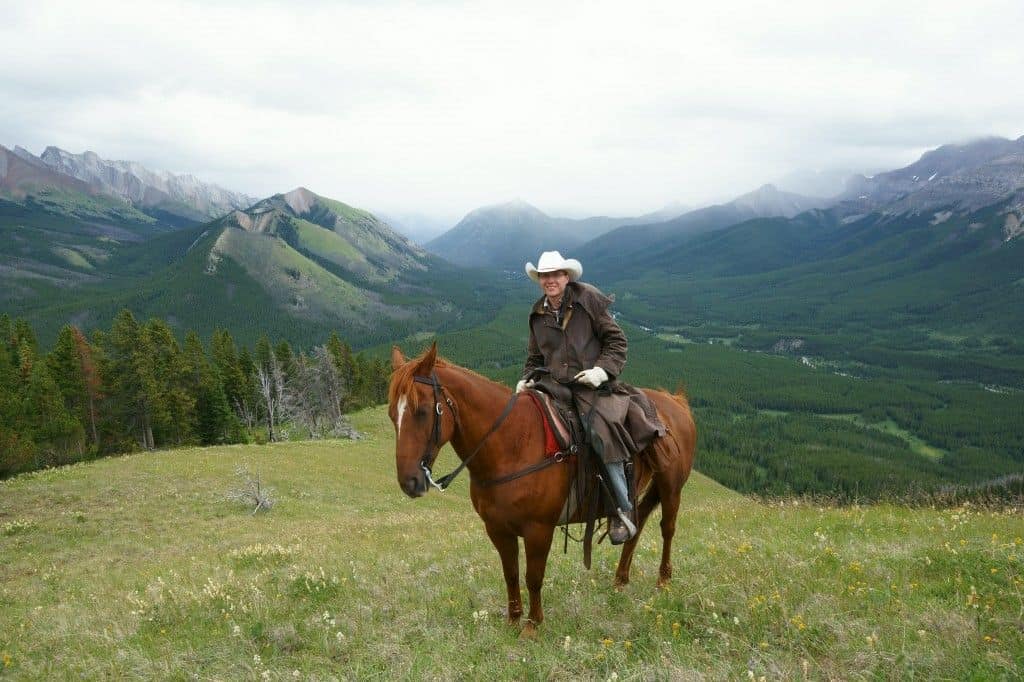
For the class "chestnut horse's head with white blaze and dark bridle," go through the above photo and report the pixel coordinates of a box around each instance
[388,343,455,498]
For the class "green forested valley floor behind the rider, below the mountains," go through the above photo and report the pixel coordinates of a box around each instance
[387,301,1024,501]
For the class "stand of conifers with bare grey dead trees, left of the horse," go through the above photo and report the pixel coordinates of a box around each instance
[0,310,388,477]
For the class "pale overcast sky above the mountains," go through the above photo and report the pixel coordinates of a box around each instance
[0,0,1024,219]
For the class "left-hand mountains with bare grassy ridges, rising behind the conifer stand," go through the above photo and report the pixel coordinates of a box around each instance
[0,147,509,344]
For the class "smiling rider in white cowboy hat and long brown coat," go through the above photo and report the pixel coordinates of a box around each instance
[516,251,666,545]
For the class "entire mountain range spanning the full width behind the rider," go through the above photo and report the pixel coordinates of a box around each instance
[0,138,1024,352]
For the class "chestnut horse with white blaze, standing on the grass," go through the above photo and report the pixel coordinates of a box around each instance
[388,344,696,635]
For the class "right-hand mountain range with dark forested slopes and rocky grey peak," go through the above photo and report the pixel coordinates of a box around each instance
[581,138,1024,345]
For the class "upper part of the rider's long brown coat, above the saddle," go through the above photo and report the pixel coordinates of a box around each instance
[522,282,627,384]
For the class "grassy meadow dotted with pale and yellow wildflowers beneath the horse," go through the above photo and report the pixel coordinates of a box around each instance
[0,409,1024,680]
